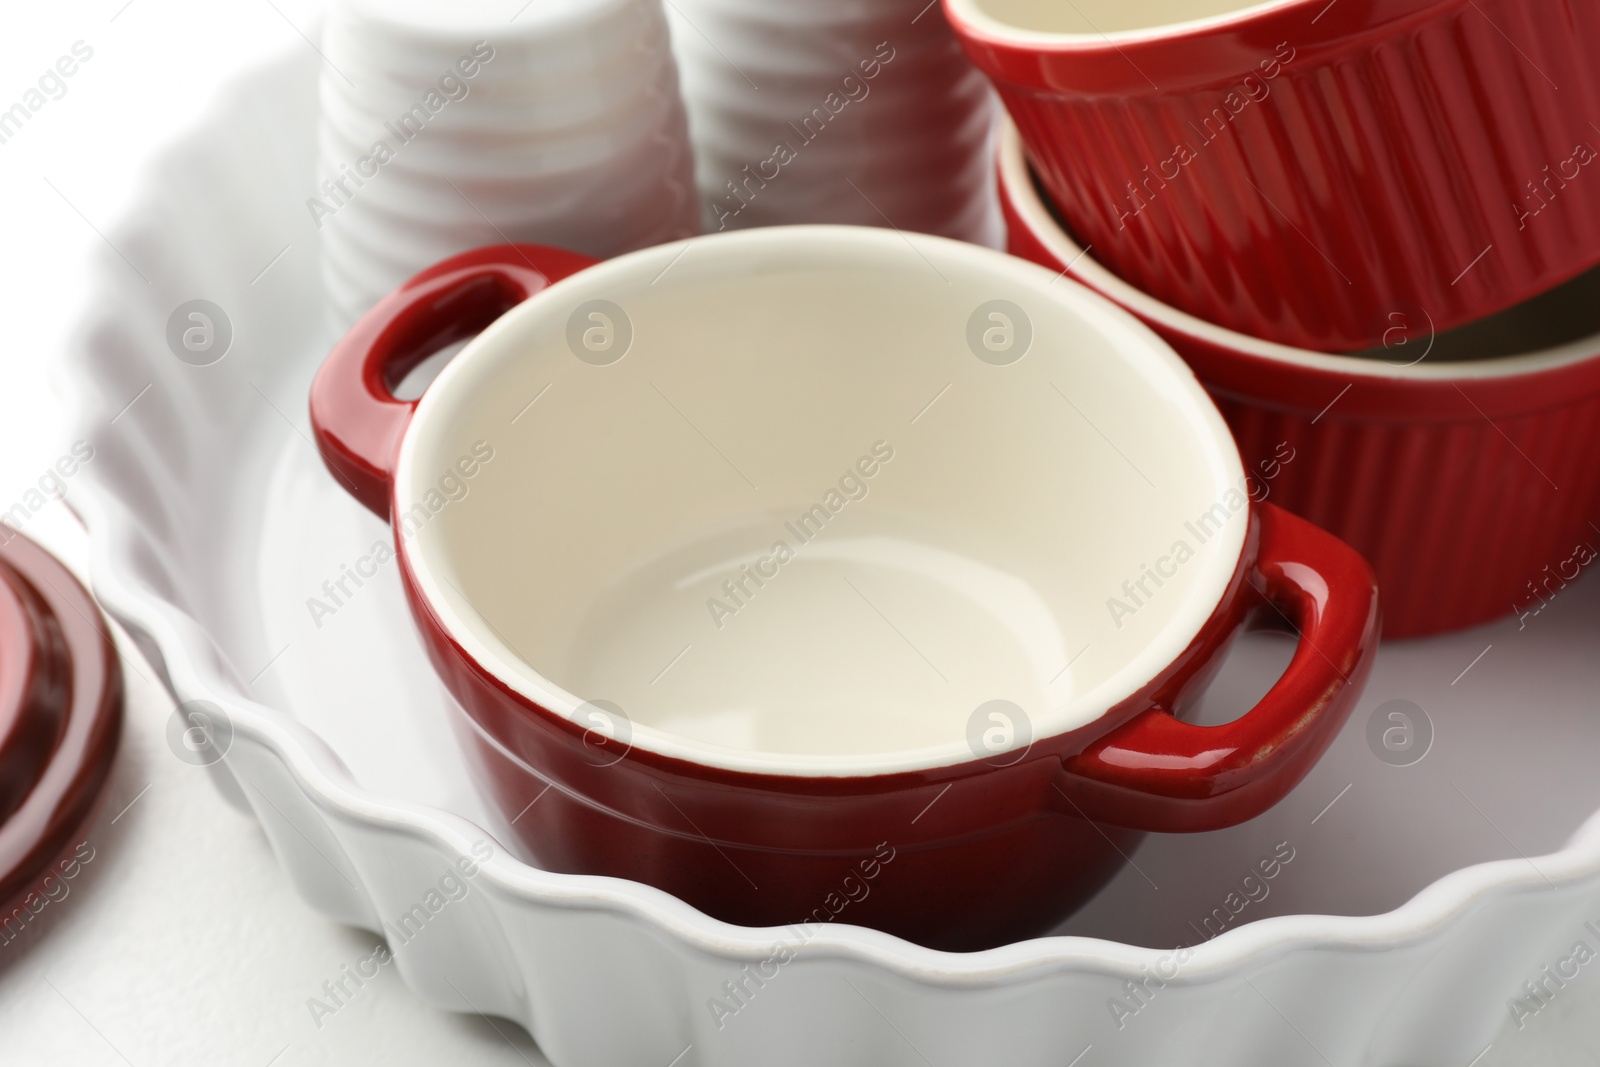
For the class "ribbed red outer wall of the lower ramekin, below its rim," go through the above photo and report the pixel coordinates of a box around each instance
[1211,386,1600,637]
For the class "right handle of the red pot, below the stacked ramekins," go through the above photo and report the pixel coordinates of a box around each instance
[1059,504,1381,833]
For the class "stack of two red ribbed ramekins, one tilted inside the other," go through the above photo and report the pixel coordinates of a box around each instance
[946,0,1600,637]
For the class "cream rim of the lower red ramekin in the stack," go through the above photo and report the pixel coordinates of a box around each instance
[998,118,1600,381]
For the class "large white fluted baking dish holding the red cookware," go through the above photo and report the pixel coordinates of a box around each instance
[62,41,1600,1067]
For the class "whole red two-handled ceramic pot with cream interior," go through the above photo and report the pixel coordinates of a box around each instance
[310,226,1378,949]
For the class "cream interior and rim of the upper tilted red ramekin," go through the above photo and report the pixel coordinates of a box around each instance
[946,0,1309,46]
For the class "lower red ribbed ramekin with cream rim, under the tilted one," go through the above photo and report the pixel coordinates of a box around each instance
[1000,123,1600,637]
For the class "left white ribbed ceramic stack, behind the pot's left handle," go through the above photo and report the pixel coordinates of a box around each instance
[318,0,699,331]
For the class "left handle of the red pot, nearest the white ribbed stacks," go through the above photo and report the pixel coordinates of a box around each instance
[310,245,598,520]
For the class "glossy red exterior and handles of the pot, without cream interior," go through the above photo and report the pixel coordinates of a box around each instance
[312,239,1379,949]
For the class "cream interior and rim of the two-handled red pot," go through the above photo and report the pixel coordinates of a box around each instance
[395,227,1248,776]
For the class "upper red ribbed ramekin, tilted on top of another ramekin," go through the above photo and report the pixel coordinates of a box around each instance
[946,0,1600,352]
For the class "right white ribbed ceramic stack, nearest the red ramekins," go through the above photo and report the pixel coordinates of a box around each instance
[667,0,1003,248]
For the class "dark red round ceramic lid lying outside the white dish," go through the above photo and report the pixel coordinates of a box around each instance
[0,526,122,918]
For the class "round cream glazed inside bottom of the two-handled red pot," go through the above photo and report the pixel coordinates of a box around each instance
[570,534,1070,755]
